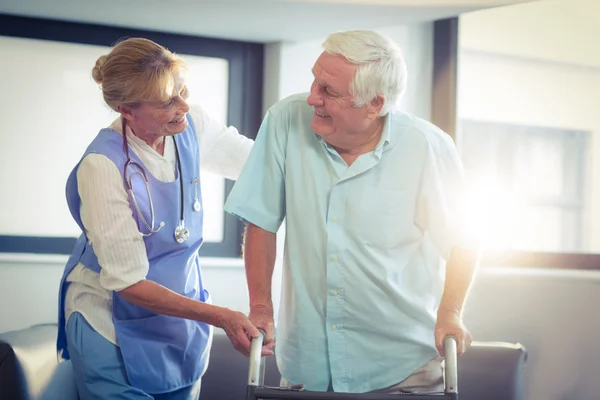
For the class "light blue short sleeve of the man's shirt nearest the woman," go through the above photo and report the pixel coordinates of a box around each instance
[225,111,288,232]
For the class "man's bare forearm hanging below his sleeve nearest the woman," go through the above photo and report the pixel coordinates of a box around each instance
[244,224,277,307]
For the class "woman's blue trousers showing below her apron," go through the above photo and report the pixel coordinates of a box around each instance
[67,312,200,400]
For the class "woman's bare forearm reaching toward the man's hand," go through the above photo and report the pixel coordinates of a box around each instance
[119,280,225,327]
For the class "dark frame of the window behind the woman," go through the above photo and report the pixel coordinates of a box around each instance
[0,14,264,258]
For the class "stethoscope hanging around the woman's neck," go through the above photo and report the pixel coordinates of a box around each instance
[122,118,201,243]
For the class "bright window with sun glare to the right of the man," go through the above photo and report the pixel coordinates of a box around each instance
[458,120,589,252]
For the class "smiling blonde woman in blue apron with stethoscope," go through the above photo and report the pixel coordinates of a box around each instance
[57,38,270,400]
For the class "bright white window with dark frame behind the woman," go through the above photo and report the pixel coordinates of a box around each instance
[0,16,263,257]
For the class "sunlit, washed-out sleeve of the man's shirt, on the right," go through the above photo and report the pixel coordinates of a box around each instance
[415,144,478,259]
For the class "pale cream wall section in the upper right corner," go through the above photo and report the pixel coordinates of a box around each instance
[460,0,600,67]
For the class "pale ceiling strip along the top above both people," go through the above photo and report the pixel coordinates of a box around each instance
[0,0,530,43]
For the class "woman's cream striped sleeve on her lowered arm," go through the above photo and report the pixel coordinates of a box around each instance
[77,154,149,291]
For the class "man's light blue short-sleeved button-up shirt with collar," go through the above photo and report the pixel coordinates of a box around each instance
[225,94,462,393]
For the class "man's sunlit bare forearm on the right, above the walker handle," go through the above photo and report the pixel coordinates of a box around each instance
[438,249,479,316]
